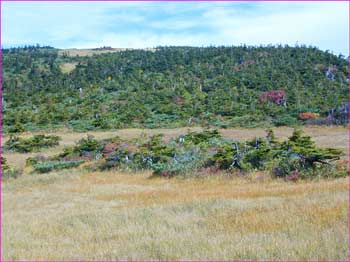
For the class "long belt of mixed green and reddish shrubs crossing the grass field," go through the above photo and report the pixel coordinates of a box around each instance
[27,130,347,180]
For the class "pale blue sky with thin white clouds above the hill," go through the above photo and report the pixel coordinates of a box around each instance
[2,2,349,55]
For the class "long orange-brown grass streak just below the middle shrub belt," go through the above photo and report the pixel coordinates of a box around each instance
[89,173,347,207]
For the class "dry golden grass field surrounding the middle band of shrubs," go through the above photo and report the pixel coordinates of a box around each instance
[2,127,349,261]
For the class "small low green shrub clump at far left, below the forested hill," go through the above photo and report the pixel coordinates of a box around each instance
[5,135,60,153]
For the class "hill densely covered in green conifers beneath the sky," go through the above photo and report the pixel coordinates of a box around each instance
[3,46,348,132]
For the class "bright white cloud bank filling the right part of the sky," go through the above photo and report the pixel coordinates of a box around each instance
[198,2,349,54]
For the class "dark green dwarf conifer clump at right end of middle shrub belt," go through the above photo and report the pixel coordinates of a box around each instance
[207,130,342,177]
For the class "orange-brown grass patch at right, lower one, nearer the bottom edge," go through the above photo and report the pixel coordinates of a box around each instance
[207,201,347,234]
